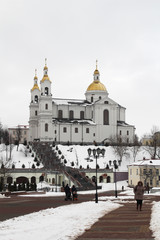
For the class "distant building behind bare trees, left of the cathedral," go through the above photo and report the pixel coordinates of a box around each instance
[8,125,29,143]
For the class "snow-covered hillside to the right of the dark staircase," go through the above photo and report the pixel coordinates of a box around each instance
[54,145,150,171]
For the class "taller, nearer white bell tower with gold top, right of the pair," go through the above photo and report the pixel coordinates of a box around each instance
[38,59,53,141]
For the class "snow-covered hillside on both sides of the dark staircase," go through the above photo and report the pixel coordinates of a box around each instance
[0,144,153,171]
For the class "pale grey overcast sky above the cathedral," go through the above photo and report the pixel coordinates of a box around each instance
[0,0,160,137]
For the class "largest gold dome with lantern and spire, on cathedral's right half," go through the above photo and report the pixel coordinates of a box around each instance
[87,60,107,91]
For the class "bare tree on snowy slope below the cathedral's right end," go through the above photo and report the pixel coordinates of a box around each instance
[110,135,129,161]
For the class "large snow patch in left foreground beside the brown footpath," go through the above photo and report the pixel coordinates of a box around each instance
[0,201,121,240]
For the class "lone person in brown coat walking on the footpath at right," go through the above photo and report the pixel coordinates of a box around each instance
[134,181,144,211]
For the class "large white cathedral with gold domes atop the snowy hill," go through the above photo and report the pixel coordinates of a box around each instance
[29,61,135,144]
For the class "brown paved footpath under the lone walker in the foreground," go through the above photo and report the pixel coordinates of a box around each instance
[77,195,160,240]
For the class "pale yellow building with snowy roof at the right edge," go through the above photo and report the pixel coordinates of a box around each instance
[128,159,160,187]
